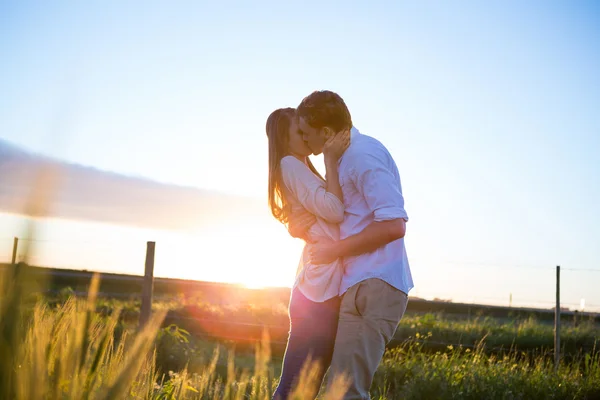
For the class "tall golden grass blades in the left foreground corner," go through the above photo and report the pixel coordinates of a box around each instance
[0,272,165,400]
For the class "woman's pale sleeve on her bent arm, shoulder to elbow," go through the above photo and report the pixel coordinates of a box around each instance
[281,157,344,224]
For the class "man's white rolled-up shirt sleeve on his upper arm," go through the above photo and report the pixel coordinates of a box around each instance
[352,151,408,221]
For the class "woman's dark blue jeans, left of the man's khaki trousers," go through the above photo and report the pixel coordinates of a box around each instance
[273,288,341,400]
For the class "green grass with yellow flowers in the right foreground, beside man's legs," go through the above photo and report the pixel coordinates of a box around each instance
[372,343,600,399]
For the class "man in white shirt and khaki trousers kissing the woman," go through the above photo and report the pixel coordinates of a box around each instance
[288,91,413,399]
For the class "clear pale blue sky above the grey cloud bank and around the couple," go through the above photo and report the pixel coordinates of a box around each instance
[0,1,600,310]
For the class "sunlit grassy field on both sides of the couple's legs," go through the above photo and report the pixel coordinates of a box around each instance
[0,268,600,400]
